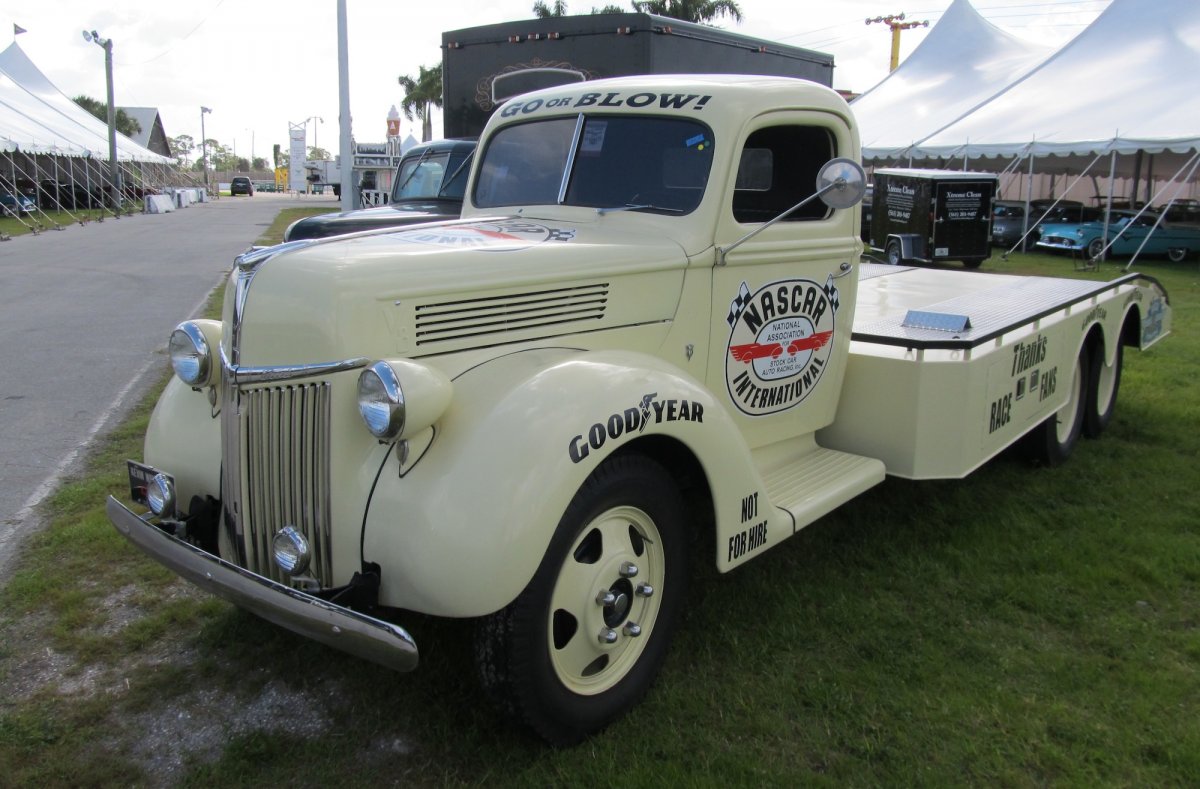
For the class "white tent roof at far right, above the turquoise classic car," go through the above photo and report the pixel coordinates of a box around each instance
[912,0,1200,167]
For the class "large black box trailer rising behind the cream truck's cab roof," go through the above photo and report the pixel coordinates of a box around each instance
[442,13,833,137]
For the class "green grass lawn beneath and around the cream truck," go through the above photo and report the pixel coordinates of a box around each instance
[0,238,1200,787]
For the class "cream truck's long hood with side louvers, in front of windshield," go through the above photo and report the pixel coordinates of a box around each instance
[226,217,688,366]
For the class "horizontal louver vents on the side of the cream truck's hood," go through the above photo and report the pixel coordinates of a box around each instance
[416,283,608,347]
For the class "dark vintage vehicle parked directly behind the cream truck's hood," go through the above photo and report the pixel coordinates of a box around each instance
[283,140,475,241]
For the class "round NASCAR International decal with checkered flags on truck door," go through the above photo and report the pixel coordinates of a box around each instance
[725,276,838,416]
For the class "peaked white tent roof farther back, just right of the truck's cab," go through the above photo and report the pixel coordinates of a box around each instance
[852,0,1052,159]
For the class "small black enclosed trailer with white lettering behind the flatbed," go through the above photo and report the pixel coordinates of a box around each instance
[870,168,997,269]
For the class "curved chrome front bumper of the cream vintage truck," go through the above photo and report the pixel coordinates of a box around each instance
[106,496,418,671]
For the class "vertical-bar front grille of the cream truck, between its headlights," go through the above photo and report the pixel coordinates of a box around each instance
[222,383,332,588]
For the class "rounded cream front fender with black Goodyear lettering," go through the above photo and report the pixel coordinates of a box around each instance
[364,349,761,616]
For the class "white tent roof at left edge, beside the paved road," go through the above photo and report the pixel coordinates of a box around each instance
[0,42,174,164]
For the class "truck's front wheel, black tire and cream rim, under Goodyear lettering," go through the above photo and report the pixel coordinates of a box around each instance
[475,454,686,745]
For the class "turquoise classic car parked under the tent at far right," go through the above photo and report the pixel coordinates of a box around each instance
[1038,211,1200,263]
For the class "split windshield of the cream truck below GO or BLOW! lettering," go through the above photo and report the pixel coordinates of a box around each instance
[474,115,713,216]
